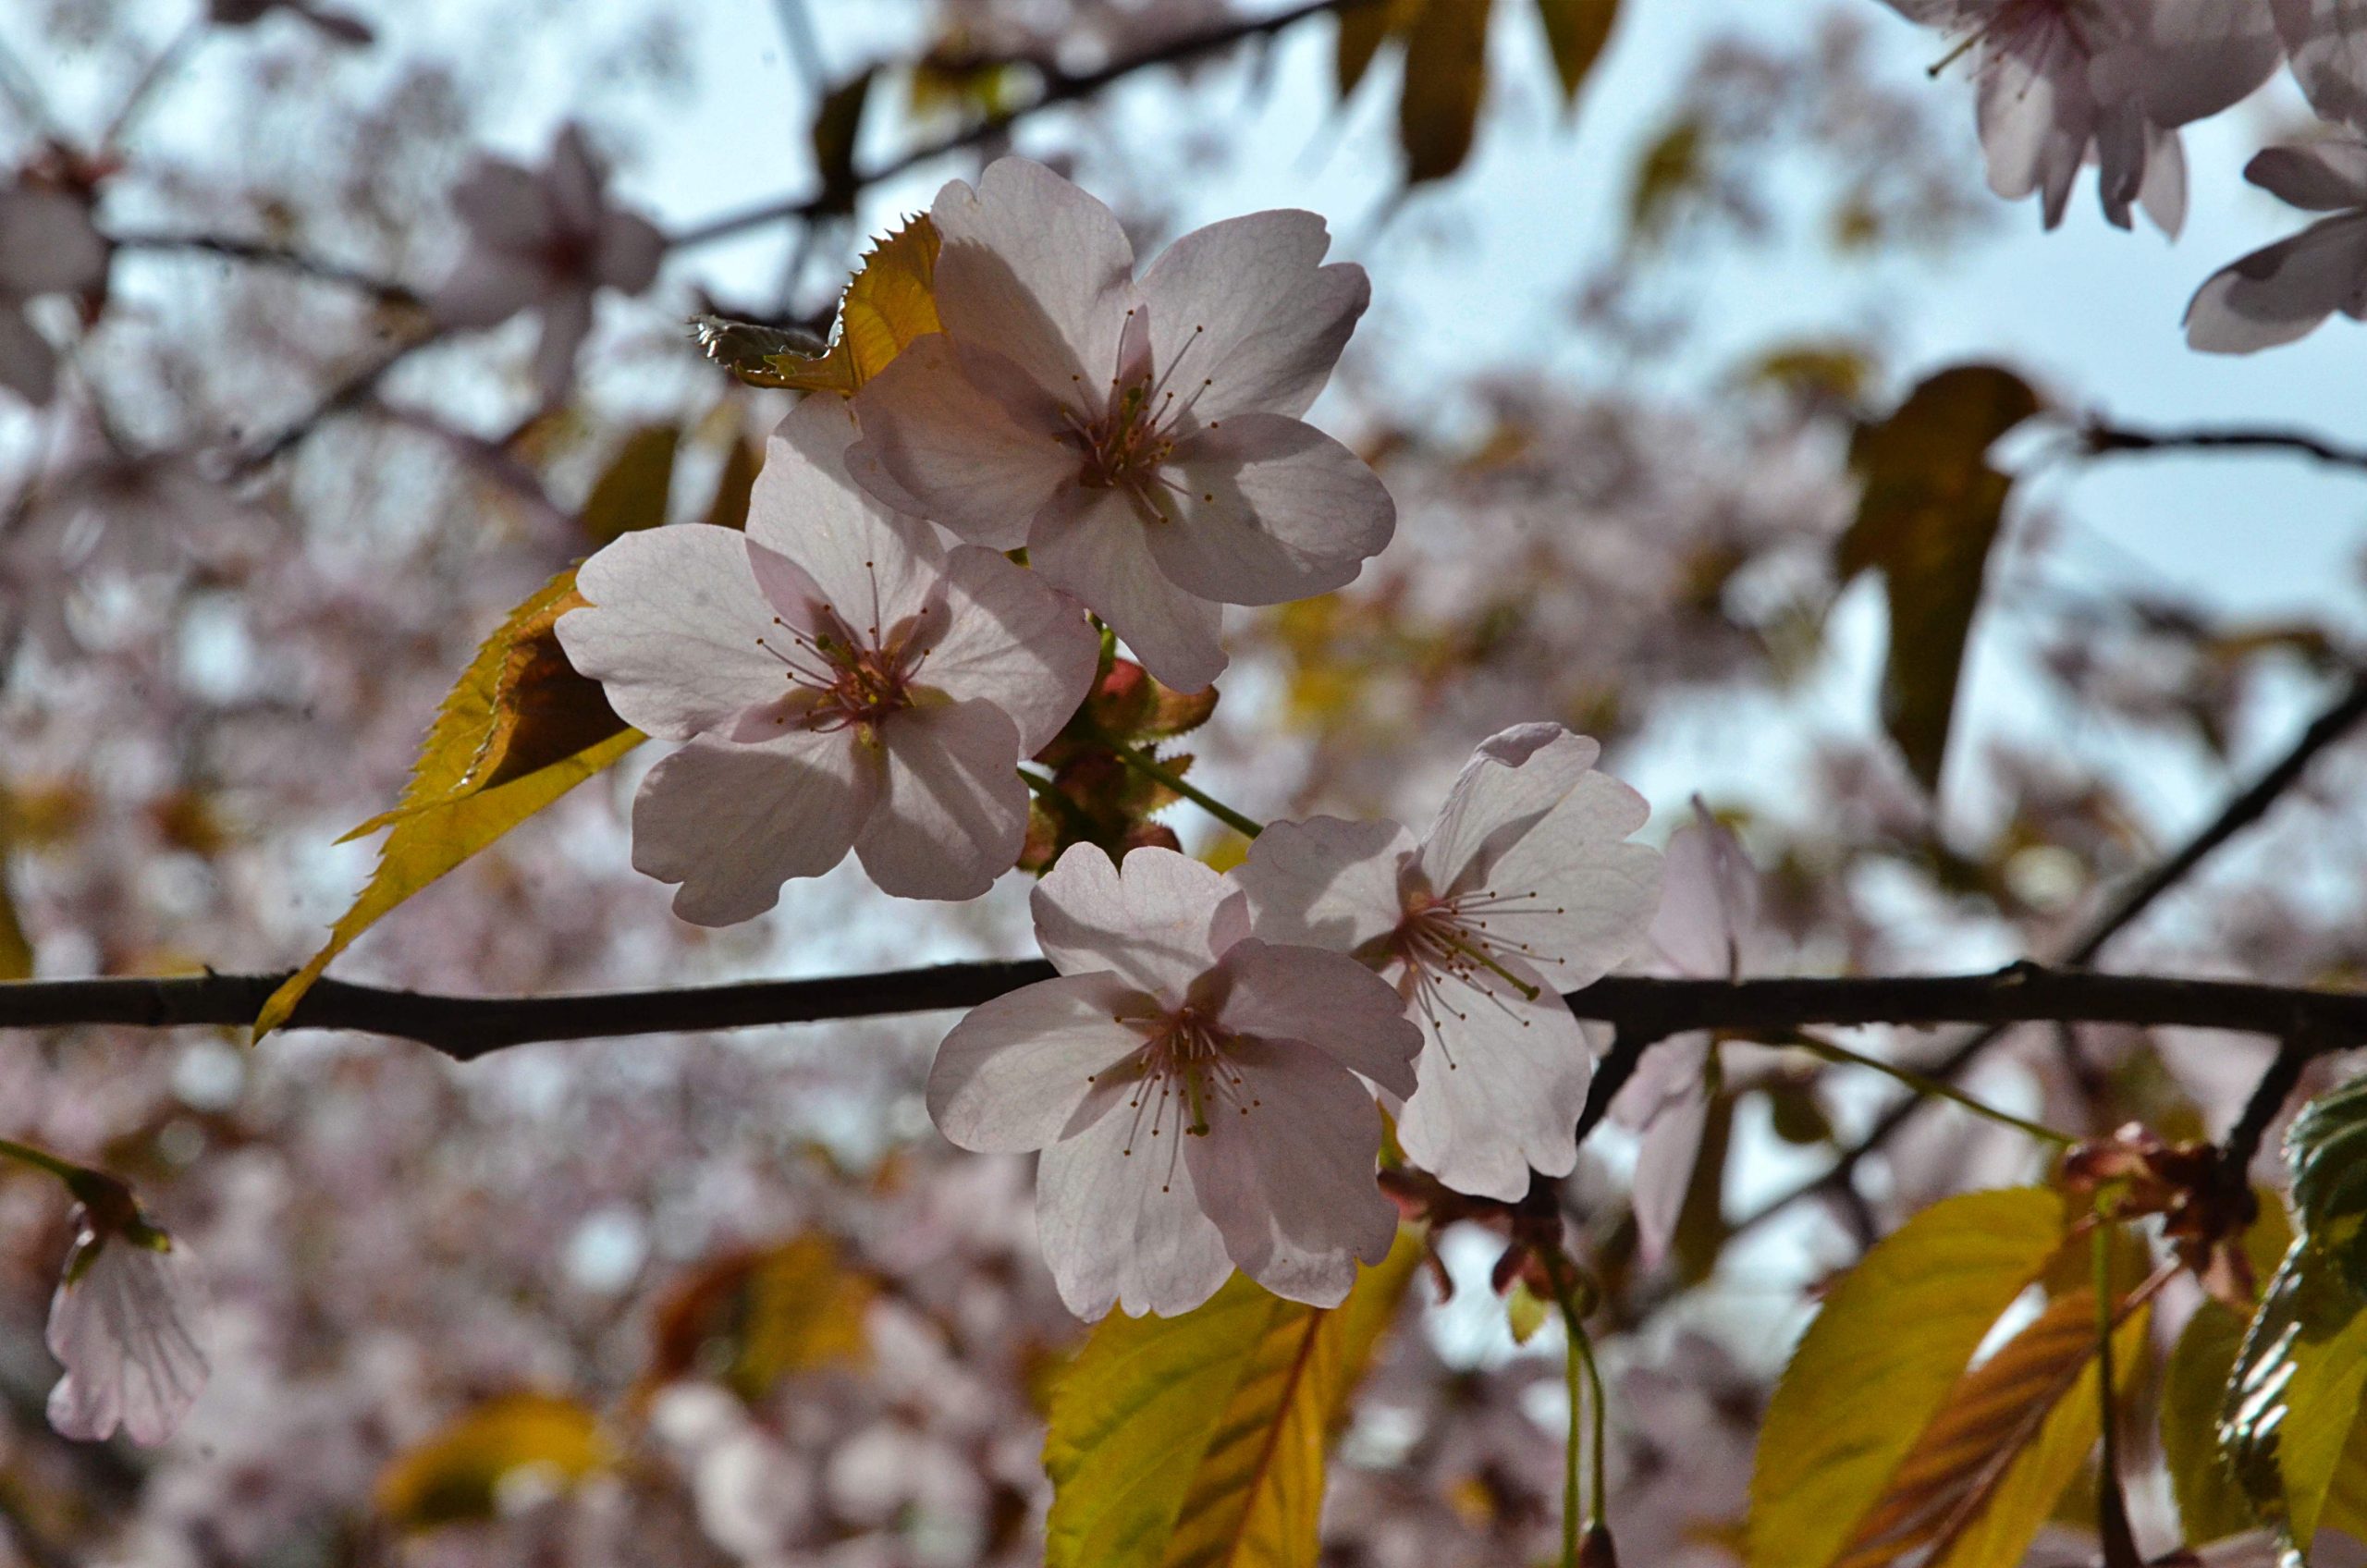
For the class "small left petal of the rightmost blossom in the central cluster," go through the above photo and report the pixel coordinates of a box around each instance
[1233,817,1417,952]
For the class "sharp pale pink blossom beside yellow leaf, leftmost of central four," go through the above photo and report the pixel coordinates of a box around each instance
[558,396,1098,926]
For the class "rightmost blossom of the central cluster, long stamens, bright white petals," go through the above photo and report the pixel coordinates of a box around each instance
[1235,725,1660,1201]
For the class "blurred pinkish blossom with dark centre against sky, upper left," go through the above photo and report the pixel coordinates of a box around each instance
[428,126,665,403]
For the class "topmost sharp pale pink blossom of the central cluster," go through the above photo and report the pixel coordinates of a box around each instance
[850,159,1396,692]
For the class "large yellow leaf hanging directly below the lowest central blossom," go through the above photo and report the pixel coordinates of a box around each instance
[1044,1231,1423,1568]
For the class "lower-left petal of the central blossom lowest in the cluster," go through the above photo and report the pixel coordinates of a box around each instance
[1036,1094,1231,1319]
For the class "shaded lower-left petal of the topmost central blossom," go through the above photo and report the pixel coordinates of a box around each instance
[845,334,1082,549]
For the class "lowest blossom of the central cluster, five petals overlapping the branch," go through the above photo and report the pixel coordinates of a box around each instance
[928,843,1423,1317]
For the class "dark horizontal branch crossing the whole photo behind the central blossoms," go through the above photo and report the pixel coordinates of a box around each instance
[0,960,2367,1061]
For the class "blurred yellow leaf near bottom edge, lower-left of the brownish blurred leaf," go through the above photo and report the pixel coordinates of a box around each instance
[374,1392,610,1530]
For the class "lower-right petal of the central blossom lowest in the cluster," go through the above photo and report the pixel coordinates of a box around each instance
[1193,1037,1396,1307]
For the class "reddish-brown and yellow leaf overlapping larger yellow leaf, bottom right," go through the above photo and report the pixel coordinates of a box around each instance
[1839,1291,2144,1568]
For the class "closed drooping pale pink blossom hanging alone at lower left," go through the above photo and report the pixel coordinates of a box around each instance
[47,1170,208,1442]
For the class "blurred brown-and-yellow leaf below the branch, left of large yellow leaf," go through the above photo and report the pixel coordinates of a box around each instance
[648,1236,878,1403]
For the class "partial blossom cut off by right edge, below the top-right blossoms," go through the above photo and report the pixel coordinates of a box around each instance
[2187,140,2367,353]
